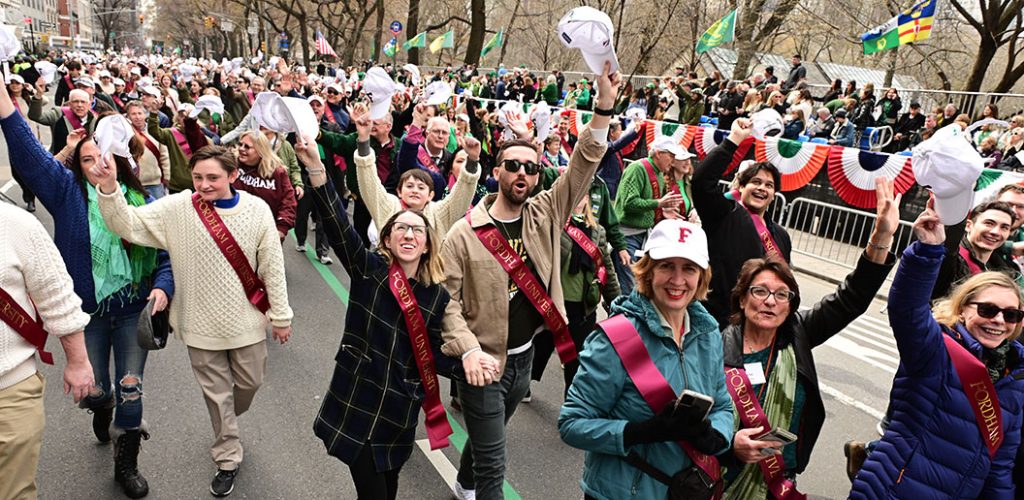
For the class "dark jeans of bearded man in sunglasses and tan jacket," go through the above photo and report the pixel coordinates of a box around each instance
[458,347,534,500]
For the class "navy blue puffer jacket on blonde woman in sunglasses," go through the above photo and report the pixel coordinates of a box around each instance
[850,242,1024,499]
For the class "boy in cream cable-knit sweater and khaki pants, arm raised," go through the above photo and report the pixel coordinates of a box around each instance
[92,145,292,497]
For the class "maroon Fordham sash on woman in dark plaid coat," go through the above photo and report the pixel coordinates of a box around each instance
[387,261,452,450]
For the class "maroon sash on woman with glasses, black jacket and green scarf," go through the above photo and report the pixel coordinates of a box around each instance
[725,367,807,500]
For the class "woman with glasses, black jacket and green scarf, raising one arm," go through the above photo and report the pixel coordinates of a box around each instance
[721,179,900,499]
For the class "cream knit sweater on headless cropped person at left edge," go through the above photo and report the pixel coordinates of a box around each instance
[0,202,89,390]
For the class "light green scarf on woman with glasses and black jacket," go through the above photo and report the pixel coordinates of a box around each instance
[725,344,797,499]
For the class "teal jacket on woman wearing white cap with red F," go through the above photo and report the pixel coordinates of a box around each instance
[558,291,733,500]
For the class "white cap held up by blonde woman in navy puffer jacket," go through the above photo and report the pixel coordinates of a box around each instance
[910,123,985,225]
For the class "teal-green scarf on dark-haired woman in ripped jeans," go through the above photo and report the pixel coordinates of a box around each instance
[85,182,157,304]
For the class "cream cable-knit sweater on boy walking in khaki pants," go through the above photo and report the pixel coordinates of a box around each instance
[98,190,292,350]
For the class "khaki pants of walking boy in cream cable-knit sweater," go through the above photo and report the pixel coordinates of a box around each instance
[188,341,266,470]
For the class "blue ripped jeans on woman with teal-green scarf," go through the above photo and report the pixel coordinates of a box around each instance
[82,313,148,429]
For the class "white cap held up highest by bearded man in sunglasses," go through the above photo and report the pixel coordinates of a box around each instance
[558,6,618,75]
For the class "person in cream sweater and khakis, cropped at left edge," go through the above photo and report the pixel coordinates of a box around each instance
[0,202,93,499]
